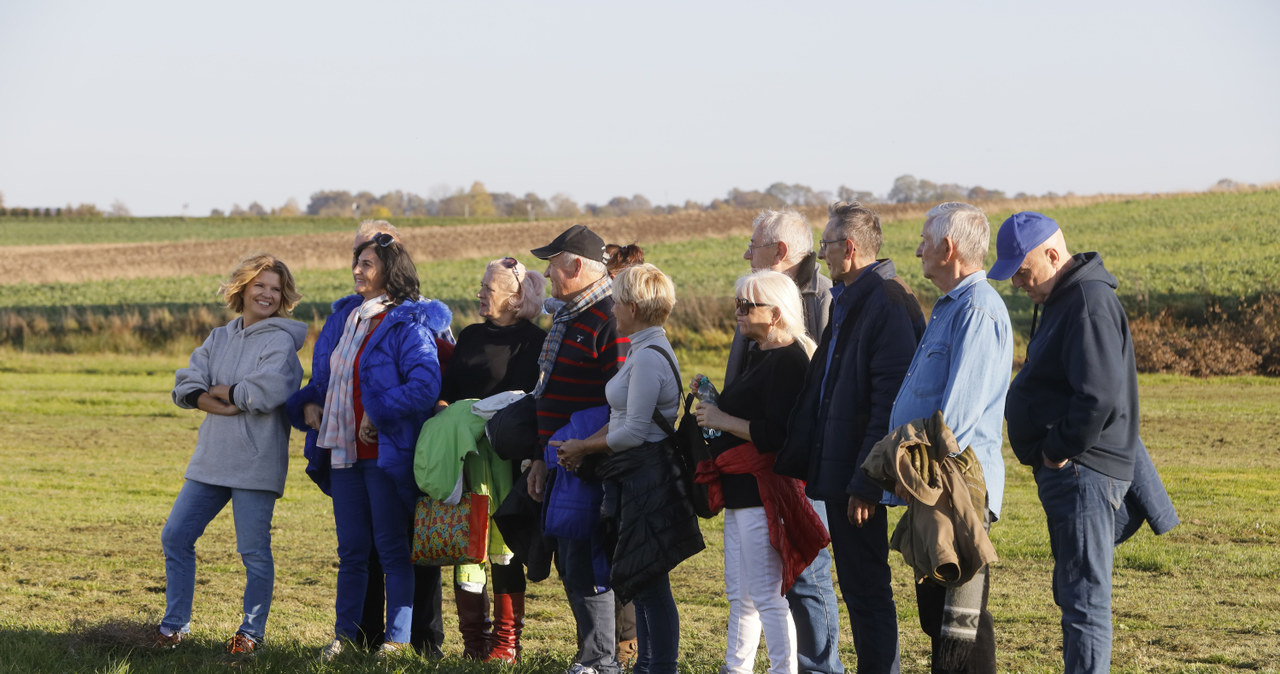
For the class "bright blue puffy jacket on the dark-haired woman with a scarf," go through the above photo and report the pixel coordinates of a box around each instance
[287,295,453,494]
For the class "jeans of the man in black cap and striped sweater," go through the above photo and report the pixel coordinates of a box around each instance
[556,538,619,674]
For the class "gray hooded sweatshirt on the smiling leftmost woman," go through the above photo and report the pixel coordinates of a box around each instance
[173,317,307,498]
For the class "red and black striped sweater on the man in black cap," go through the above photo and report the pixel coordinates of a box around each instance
[536,297,631,446]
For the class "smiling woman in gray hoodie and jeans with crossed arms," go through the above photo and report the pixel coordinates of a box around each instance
[155,253,307,655]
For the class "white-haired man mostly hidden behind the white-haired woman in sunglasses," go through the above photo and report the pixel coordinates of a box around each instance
[724,208,845,674]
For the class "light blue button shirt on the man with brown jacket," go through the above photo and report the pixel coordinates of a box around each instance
[890,271,1014,518]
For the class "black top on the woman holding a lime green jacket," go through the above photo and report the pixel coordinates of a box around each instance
[440,321,547,404]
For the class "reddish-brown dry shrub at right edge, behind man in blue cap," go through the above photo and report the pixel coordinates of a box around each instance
[1129,294,1280,377]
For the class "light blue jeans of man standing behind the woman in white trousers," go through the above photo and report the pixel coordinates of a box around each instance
[787,499,845,674]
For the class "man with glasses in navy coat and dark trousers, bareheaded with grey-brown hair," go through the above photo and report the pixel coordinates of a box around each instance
[776,202,924,673]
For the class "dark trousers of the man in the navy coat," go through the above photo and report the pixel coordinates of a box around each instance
[826,500,901,674]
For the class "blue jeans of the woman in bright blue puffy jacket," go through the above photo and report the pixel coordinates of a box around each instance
[330,459,416,643]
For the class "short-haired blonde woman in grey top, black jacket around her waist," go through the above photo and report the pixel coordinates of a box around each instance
[553,263,704,674]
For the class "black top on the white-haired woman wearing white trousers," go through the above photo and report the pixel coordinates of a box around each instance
[710,343,809,508]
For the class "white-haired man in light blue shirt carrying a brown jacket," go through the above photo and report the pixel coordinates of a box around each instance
[888,202,1014,674]
